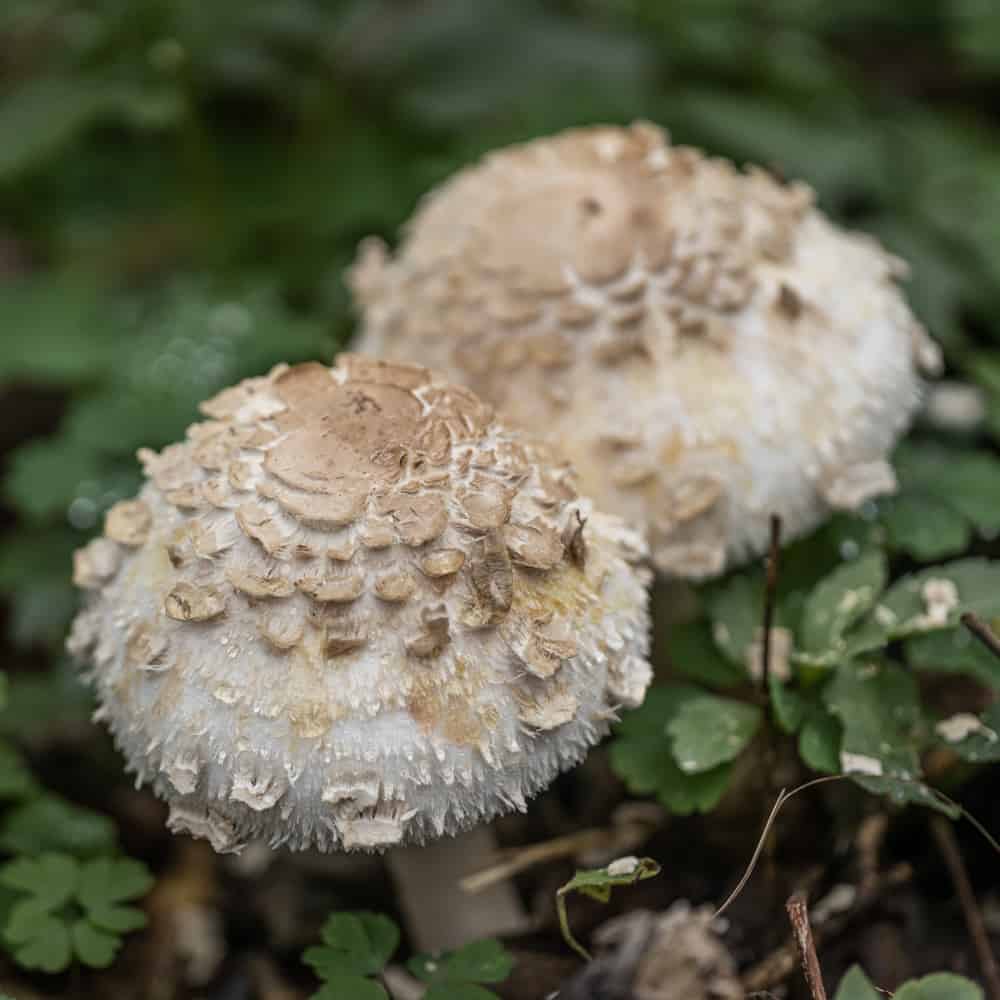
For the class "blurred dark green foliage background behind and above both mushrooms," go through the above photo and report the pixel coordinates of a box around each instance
[0,0,1000,652]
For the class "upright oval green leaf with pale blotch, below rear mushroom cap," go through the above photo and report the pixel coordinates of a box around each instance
[799,552,888,655]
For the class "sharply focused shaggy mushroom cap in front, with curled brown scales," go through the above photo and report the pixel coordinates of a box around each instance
[69,355,650,851]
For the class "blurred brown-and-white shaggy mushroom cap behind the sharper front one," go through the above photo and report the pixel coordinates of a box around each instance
[351,123,939,578]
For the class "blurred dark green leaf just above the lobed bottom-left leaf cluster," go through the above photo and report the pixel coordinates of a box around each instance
[0,795,118,857]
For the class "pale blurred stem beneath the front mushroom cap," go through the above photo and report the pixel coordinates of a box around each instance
[386,827,529,952]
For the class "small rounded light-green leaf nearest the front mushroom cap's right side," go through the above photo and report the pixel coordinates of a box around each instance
[666,691,763,774]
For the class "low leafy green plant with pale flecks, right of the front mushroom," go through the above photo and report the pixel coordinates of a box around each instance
[611,480,1000,814]
